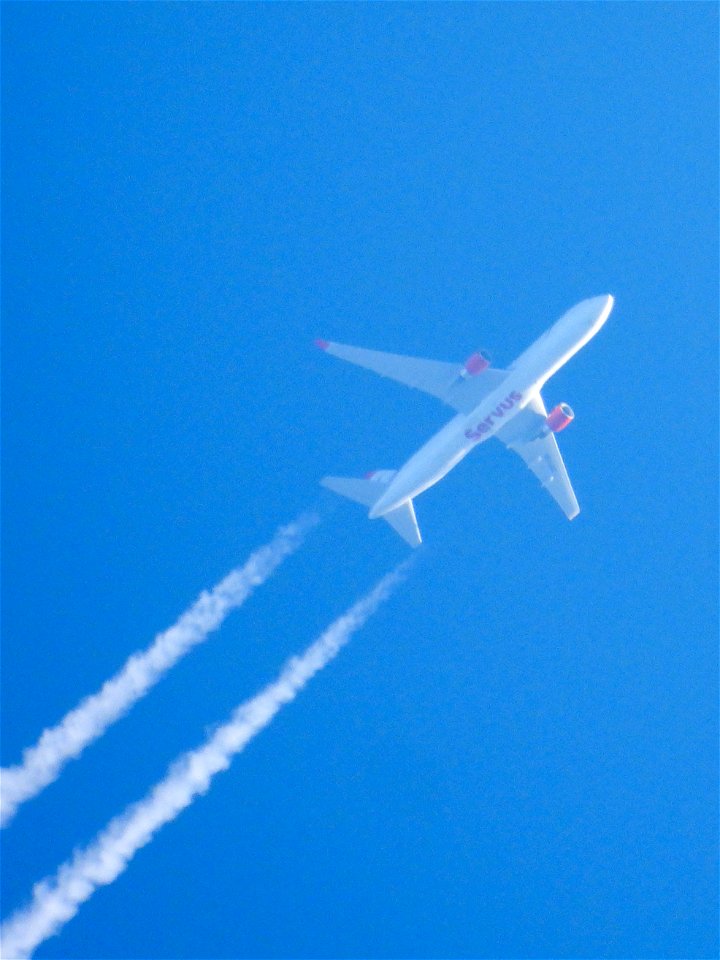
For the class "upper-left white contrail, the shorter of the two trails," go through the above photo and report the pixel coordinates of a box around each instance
[0,513,320,827]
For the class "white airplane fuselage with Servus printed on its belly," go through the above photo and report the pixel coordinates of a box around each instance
[369,296,613,519]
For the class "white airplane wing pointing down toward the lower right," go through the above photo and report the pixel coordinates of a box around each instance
[496,393,580,520]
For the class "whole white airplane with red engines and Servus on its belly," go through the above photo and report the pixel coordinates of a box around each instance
[315,294,614,547]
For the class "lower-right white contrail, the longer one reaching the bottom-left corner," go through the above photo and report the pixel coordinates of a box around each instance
[0,562,408,960]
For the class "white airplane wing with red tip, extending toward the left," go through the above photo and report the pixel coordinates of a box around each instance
[316,340,507,413]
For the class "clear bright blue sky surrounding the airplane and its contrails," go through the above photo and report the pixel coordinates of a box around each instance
[2,3,718,960]
